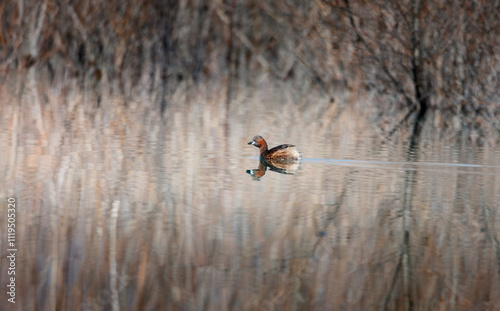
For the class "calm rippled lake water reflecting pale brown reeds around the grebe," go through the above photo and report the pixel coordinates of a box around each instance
[0,81,500,311]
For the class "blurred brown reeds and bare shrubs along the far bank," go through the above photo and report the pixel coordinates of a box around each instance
[0,0,500,140]
